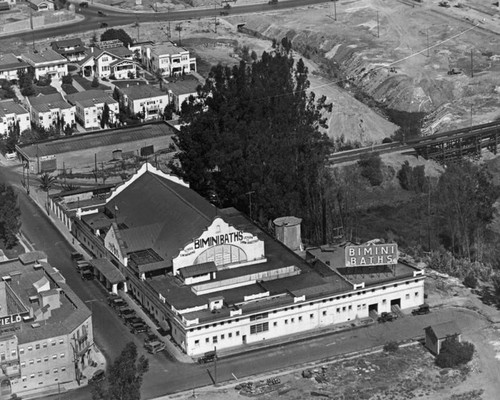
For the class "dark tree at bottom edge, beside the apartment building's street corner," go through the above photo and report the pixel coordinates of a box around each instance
[92,342,149,400]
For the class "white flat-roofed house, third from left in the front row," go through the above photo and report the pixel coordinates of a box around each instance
[66,90,120,129]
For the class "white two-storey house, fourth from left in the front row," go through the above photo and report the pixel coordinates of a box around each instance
[120,85,168,120]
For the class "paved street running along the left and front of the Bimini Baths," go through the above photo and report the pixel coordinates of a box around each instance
[0,160,492,400]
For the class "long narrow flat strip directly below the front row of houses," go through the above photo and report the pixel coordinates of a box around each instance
[18,121,174,158]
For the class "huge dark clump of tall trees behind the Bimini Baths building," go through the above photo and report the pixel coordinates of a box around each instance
[172,48,332,241]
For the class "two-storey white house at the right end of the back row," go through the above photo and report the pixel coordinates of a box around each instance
[141,42,196,76]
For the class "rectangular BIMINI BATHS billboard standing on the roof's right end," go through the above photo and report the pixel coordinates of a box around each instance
[345,243,398,267]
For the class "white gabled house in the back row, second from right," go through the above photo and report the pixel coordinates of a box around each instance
[93,46,137,79]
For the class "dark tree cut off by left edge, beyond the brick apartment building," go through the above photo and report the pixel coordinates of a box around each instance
[0,183,21,249]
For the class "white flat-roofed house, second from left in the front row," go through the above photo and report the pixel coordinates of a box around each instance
[28,93,75,130]
